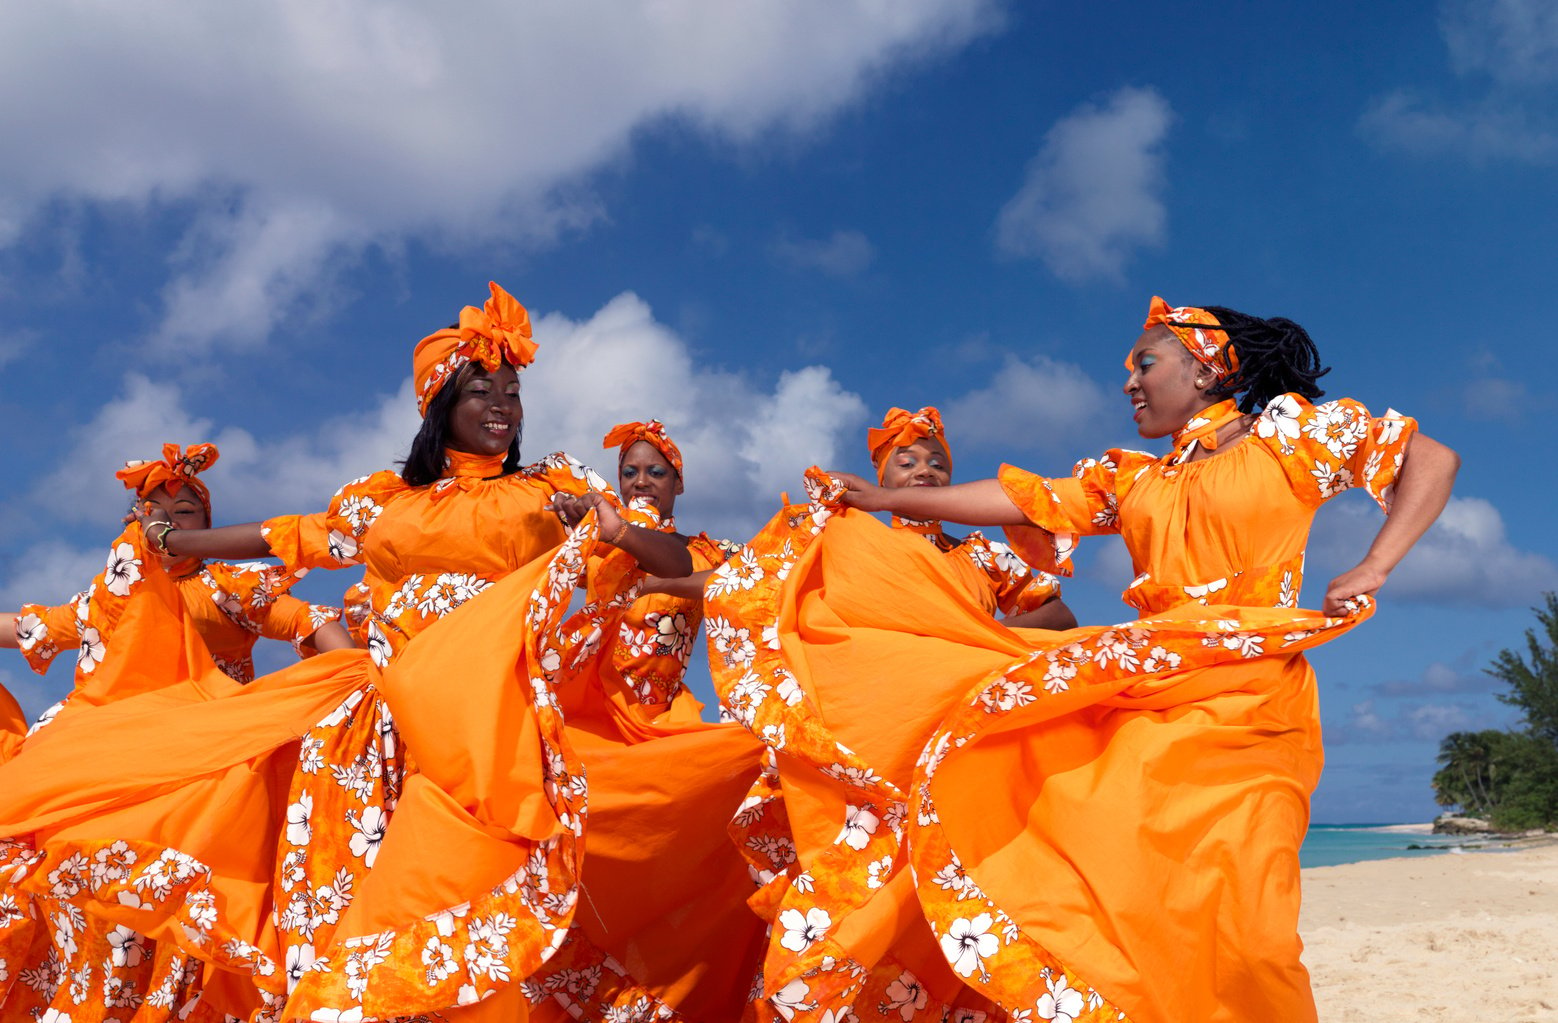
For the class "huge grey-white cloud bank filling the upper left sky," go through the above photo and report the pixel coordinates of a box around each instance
[0,0,1000,346]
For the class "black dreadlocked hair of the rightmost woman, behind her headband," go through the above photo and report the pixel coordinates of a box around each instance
[1197,305,1331,414]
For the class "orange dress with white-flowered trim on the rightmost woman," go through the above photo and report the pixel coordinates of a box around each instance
[707,394,1416,1023]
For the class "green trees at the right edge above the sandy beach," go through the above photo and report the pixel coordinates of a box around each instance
[1433,593,1558,831]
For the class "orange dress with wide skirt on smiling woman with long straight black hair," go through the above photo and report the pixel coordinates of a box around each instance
[0,453,760,1020]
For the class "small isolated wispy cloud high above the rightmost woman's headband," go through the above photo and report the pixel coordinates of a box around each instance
[996,89,1173,282]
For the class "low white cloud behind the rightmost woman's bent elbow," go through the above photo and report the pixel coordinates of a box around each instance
[1306,497,1558,607]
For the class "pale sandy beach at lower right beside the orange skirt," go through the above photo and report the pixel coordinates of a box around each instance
[1299,839,1558,1023]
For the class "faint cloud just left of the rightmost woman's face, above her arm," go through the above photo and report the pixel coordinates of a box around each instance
[943,355,1130,454]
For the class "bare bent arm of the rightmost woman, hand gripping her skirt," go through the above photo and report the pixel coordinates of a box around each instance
[1321,433,1460,615]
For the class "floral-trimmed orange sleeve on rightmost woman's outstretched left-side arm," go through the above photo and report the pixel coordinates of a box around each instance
[997,448,1158,576]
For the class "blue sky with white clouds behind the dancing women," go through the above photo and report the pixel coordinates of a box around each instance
[0,0,1558,822]
